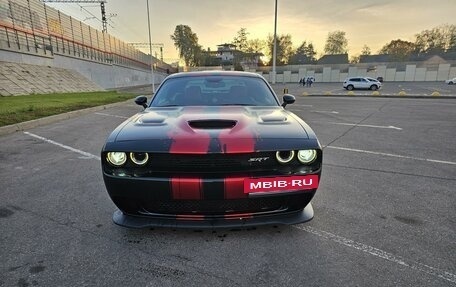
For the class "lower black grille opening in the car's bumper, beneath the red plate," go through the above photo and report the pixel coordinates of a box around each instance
[139,193,313,216]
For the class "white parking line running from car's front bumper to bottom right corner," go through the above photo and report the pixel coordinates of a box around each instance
[293,225,456,283]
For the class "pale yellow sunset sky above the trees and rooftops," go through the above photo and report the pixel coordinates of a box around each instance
[47,0,456,62]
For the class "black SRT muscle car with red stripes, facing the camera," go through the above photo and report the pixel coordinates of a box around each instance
[101,71,322,228]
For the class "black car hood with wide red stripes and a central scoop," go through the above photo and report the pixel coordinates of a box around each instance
[107,106,319,153]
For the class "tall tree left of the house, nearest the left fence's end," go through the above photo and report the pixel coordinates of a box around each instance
[171,25,202,66]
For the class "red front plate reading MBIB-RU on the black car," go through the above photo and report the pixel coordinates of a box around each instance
[244,174,318,193]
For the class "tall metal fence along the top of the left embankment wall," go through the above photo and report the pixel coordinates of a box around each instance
[0,0,171,71]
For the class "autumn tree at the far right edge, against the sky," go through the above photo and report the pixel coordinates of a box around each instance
[415,24,456,53]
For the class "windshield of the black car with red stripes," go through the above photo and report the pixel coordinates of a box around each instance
[150,75,279,107]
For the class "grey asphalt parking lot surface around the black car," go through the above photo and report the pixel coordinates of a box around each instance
[0,86,456,286]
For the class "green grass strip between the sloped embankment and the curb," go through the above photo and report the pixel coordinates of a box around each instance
[0,91,135,126]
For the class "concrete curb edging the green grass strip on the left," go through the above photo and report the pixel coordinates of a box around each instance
[0,100,132,136]
